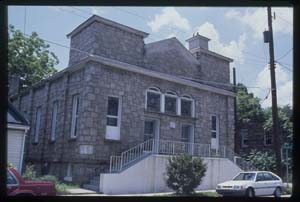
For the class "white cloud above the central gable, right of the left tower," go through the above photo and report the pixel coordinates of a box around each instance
[147,7,191,32]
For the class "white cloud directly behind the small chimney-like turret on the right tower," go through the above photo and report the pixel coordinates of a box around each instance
[196,22,246,64]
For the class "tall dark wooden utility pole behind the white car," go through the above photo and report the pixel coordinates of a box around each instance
[264,6,282,177]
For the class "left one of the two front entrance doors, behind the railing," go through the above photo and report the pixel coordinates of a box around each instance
[144,119,159,152]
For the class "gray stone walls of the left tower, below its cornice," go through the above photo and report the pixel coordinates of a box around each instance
[69,22,144,65]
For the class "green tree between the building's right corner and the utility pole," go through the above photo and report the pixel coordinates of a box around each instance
[236,83,263,123]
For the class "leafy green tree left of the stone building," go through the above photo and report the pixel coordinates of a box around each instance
[8,25,59,87]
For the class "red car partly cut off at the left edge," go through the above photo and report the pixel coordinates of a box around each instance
[6,167,56,196]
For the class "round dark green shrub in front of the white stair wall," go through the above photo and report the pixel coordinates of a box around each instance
[166,154,207,195]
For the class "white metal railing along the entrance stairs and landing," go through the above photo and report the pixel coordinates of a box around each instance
[110,139,256,173]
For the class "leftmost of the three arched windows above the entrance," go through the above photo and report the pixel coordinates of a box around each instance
[145,87,163,112]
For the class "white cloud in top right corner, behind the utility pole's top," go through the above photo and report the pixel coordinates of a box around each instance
[225,8,293,39]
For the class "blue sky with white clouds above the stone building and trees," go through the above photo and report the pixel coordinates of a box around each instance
[8,6,293,107]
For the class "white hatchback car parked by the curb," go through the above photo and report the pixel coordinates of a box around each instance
[216,171,284,197]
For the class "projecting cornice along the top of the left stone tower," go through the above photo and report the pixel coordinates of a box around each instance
[67,15,149,38]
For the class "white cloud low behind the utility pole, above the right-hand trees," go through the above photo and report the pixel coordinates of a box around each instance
[252,64,293,107]
